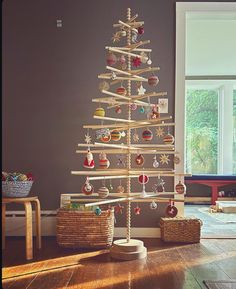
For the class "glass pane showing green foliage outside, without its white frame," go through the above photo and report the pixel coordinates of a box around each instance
[185,88,219,174]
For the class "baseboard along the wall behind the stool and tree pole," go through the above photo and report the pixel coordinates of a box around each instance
[6,211,160,238]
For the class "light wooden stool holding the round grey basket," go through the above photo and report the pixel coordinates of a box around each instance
[2,197,41,260]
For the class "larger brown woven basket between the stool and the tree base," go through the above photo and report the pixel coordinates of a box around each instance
[57,208,114,248]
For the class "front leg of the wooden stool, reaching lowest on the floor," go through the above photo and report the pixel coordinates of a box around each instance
[24,202,33,260]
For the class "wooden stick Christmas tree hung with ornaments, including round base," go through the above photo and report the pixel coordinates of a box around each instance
[71,8,189,260]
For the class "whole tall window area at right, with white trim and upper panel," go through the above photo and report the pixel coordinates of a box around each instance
[175,2,236,175]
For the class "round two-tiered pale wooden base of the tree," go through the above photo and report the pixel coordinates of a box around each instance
[110,239,147,260]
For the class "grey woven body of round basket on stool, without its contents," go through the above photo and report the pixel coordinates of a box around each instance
[2,181,33,198]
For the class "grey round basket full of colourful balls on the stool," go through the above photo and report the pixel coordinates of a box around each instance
[2,172,34,198]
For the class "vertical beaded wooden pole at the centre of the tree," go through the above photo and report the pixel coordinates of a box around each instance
[126,8,131,242]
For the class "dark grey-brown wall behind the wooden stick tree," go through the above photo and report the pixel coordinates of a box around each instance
[2,0,234,223]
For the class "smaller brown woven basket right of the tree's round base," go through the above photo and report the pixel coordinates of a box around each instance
[160,217,202,243]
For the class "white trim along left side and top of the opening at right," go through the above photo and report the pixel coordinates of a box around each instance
[175,2,236,173]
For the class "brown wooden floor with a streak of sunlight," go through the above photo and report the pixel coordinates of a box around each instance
[2,237,236,289]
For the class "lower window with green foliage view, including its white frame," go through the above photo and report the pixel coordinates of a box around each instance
[185,81,236,175]
